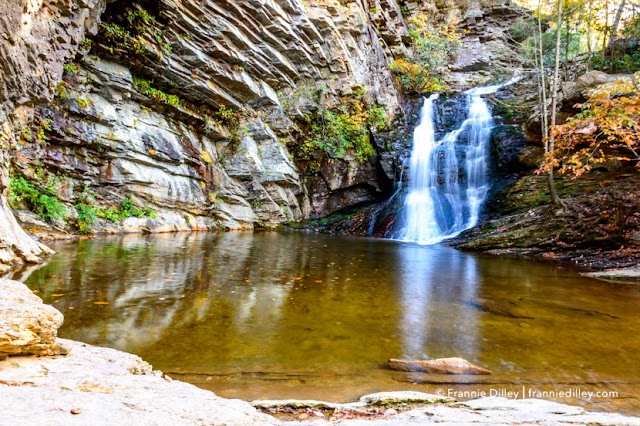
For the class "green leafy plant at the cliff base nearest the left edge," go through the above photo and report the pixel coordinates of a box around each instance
[9,177,67,221]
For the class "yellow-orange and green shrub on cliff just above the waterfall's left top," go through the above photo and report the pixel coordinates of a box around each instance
[389,15,460,93]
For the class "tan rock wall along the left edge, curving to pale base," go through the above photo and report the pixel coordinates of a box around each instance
[0,0,105,271]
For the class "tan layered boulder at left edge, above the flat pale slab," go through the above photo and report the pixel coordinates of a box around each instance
[0,279,64,359]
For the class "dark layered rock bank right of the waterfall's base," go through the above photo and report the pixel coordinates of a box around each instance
[449,170,640,269]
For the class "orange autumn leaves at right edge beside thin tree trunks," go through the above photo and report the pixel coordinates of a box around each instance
[540,73,640,177]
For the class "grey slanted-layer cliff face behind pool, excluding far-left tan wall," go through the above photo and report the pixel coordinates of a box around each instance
[7,0,407,240]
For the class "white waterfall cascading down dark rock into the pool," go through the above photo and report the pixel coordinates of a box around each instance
[395,80,514,244]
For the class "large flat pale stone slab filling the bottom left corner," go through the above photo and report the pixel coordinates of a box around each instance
[0,340,280,426]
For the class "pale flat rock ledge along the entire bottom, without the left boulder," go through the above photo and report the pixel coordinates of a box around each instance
[0,340,640,426]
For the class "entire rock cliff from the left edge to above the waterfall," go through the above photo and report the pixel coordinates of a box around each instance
[0,0,528,272]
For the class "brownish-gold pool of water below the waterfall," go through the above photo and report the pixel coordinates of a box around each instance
[15,232,640,414]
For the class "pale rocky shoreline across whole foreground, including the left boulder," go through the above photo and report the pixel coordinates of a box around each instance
[0,280,640,426]
